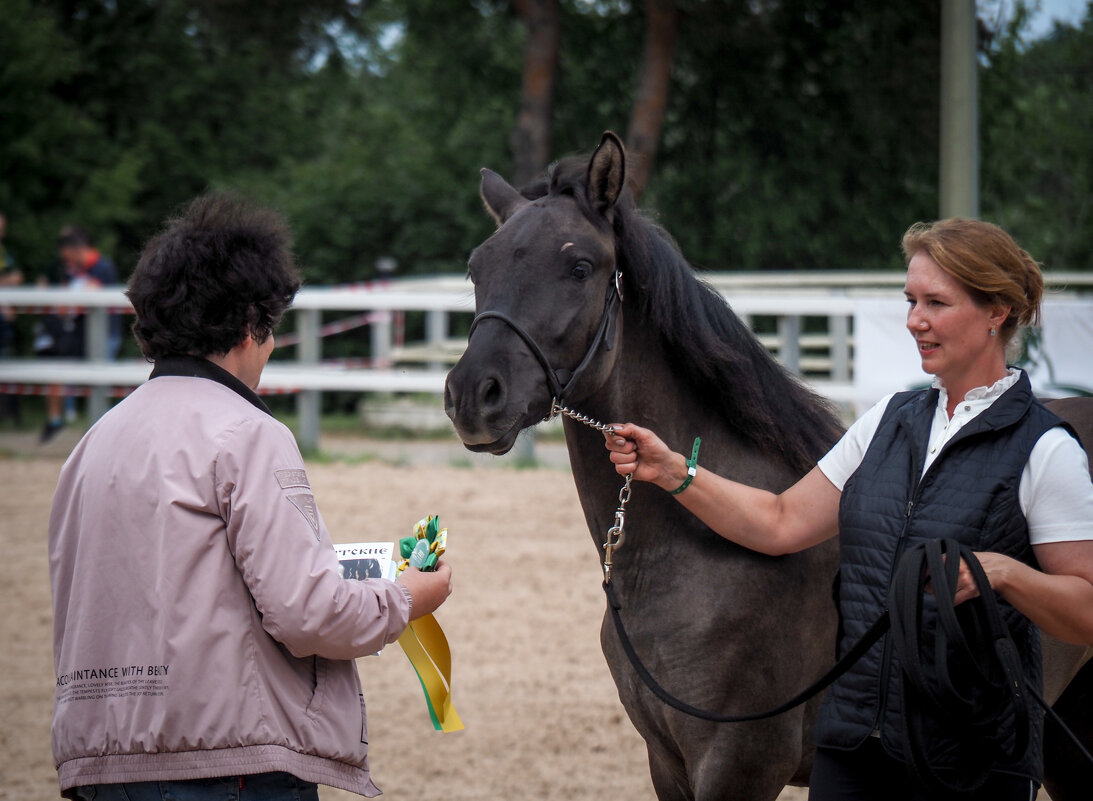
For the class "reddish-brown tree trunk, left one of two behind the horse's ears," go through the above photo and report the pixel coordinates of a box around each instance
[509,0,562,187]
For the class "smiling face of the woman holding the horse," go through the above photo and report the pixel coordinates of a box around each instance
[904,251,1009,392]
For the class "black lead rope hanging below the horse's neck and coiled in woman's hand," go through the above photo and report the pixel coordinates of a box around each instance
[603,540,1093,791]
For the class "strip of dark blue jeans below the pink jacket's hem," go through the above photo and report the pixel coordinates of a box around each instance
[75,774,319,801]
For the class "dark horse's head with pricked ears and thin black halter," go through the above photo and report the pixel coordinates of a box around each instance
[444,132,625,455]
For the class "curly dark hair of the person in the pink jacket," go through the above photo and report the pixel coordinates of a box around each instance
[126,193,299,361]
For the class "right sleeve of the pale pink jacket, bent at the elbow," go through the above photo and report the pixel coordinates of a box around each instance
[215,419,410,659]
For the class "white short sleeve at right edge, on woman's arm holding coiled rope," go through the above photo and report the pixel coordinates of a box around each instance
[1018,427,1093,545]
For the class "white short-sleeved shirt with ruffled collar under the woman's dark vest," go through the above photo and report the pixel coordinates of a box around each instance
[819,368,1093,545]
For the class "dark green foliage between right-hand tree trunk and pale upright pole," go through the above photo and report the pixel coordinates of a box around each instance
[647,0,939,270]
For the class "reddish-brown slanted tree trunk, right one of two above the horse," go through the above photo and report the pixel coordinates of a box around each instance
[626,0,679,198]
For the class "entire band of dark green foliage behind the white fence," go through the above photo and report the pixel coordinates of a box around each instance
[0,0,1093,283]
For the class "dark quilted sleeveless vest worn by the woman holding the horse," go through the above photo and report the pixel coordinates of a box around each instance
[815,374,1063,781]
